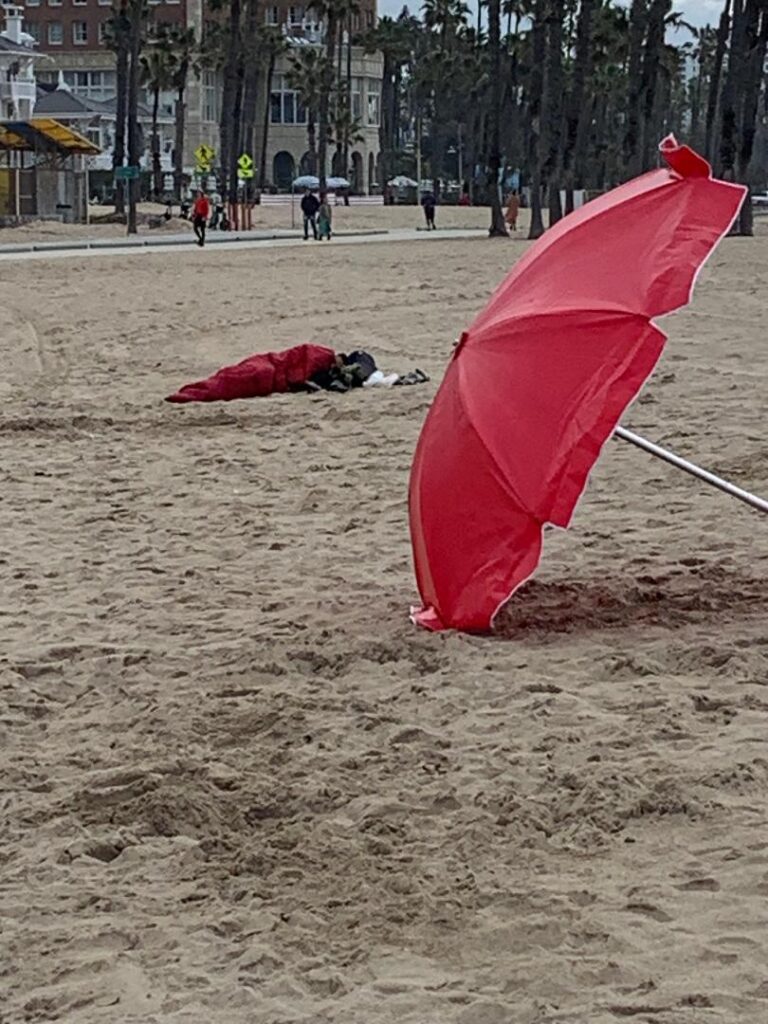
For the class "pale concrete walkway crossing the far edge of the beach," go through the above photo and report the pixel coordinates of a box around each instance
[0,227,487,262]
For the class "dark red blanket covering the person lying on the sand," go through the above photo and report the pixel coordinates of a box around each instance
[166,345,336,401]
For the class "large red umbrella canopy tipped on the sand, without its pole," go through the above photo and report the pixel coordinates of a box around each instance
[411,136,745,631]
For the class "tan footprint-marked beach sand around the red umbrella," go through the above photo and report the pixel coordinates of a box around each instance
[0,211,768,1024]
